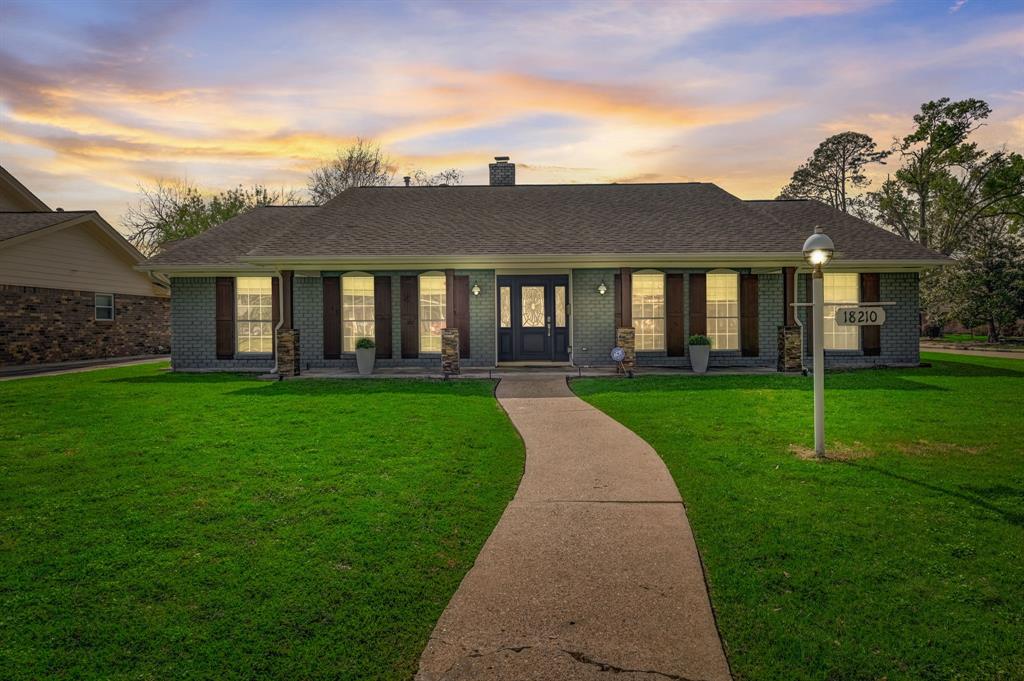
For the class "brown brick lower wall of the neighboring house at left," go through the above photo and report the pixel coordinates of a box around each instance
[0,285,171,367]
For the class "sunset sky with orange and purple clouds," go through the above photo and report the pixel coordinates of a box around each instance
[0,0,1024,229]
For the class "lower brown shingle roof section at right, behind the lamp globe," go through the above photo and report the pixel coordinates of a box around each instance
[746,199,947,262]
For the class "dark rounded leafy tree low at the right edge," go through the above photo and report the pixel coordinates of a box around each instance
[923,216,1024,343]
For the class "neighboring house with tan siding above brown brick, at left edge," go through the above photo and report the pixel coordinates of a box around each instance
[0,167,170,367]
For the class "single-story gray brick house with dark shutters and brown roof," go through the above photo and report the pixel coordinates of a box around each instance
[140,157,944,374]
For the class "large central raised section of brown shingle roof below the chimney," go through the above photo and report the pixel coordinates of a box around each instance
[250,182,806,257]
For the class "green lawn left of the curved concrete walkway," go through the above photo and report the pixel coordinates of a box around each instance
[0,365,523,679]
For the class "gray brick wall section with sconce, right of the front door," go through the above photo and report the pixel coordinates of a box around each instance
[570,269,616,367]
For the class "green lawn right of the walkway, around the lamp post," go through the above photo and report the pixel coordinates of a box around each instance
[572,354,1024,681]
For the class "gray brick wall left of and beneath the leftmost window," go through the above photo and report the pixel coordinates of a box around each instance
[171,276,273,371]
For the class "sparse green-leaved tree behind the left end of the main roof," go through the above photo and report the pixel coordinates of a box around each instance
[121,180,302,255]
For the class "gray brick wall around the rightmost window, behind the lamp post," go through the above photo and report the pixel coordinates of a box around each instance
[797,272,921,369]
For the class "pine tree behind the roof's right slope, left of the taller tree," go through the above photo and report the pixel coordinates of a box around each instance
[778,132,889,213]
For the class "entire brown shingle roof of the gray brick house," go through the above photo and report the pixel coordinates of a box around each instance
[145,182,941,269]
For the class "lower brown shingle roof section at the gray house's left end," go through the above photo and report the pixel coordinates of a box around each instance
[146,206,316,265]
